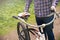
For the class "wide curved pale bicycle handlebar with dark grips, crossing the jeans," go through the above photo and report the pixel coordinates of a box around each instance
[13,13,60,28]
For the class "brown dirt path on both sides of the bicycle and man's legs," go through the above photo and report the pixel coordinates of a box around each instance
[0,19,60,40]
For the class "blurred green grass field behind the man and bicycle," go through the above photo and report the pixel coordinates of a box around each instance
[0,0,60,35]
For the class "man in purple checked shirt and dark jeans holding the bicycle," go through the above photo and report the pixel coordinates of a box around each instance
[18,0,58,40]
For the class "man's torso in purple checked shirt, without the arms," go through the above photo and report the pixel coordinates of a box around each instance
[34,0,52,17]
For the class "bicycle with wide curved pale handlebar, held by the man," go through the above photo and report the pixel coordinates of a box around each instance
[13,13,60,40]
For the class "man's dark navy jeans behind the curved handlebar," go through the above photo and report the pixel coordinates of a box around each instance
[36,16,55,40]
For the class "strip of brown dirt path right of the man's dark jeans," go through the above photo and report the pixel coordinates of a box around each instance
[54,19,60,40]
